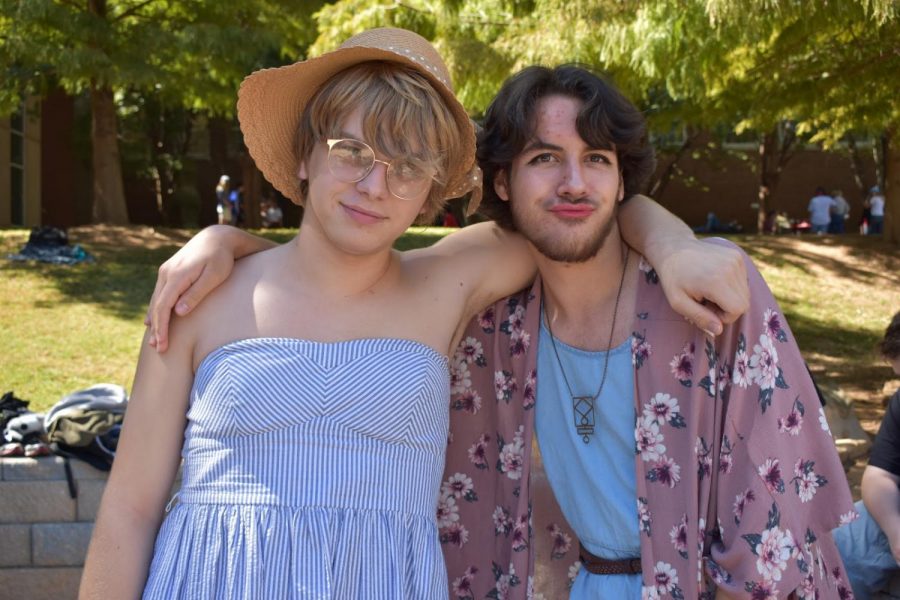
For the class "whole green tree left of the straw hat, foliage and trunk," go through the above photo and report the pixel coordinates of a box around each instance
[0,0,321,223]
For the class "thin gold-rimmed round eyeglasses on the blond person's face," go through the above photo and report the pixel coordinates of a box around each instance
[325,138,436,200]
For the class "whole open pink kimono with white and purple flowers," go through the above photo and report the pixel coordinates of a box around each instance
[438,244,856,600]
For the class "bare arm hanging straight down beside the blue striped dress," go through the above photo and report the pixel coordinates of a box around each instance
[79,328,193,599]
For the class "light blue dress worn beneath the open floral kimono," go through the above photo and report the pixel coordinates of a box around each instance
[535,319,641,600]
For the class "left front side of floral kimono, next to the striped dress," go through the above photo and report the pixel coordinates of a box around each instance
[437,291,540,600]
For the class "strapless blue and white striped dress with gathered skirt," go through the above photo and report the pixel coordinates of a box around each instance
[144,338,449,600]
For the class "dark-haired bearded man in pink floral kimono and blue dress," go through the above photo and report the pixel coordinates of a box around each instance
[438,66,855,600]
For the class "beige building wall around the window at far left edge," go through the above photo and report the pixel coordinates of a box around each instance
[0,98,41,227]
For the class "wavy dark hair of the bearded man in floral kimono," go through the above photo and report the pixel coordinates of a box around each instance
[477,65,656,229]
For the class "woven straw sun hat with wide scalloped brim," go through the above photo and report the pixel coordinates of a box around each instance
[237,27,481,214]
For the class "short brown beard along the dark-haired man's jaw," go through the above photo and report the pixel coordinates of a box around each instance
[510,202,619,263]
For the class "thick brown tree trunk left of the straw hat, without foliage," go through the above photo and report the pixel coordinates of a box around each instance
[91,86,128,225]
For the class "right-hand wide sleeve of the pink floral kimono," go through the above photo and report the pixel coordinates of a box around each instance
[706,241,856,599]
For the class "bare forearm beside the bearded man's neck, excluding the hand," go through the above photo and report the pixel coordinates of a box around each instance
[619,194,694,268]
